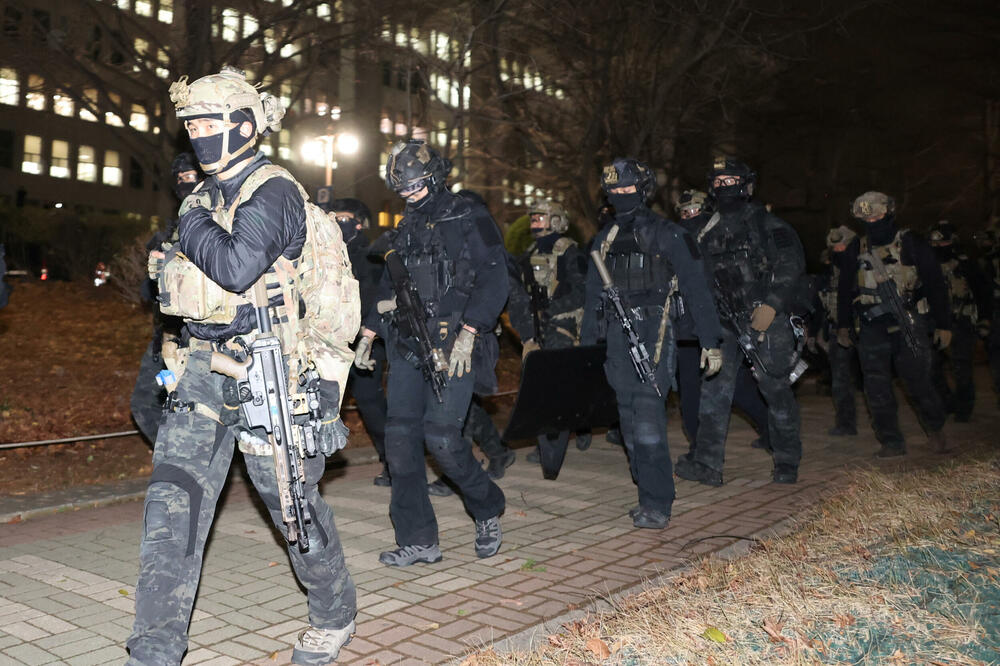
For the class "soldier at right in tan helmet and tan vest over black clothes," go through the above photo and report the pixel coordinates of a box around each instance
[837,192,951,458]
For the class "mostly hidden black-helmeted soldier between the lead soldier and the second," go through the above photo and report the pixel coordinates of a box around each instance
[328,199,392,487]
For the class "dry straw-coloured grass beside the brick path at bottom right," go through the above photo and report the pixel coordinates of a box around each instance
[463,454,1000,666]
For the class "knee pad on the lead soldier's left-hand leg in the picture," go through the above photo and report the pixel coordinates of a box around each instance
[143,464,204,557]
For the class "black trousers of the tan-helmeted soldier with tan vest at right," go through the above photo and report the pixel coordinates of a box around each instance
[858,318,947,449]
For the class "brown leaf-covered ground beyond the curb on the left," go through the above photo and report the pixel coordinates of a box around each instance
[0,281,520,495]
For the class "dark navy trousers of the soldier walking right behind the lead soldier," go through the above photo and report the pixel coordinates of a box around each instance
[385,345,505,546]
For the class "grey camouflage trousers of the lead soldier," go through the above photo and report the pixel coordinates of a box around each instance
[127,351,357,666]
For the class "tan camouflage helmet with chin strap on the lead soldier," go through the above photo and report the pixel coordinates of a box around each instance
[170,65,285,173]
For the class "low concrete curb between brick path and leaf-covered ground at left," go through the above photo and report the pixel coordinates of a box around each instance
[0,447,378,525]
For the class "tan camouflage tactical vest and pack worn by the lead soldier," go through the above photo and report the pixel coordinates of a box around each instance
[159,164,361,398]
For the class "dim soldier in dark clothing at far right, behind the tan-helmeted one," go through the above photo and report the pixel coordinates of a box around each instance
[927,220,989,423]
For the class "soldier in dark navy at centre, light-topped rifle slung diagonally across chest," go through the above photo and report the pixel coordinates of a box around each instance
[581,158,728,529]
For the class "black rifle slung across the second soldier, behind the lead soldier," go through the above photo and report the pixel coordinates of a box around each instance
[385,250,448,403]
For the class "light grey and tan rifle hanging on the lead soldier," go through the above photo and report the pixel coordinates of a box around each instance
[211,278,322,553]
